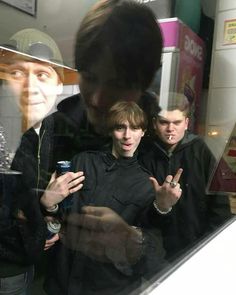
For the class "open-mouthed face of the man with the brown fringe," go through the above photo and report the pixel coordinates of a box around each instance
[111,121,144,158]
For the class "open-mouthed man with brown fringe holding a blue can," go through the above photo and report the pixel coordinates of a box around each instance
[42,101,165,295]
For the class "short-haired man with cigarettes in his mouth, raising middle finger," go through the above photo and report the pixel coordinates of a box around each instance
[140,93,231,261]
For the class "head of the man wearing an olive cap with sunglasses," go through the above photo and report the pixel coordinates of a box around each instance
[1,29,64,131]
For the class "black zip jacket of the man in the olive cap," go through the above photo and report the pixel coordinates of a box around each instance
[0,96,84,277]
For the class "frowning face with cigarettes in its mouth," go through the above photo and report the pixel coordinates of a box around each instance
[153,110,189,149]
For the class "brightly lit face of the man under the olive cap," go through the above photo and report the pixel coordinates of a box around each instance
[7,61,62,128]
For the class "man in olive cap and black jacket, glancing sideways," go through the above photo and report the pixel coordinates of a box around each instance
[0,29,74,294]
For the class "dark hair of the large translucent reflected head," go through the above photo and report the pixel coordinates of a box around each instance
[75,0,162,91]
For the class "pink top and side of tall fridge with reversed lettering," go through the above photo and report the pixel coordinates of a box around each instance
[160,18,205,132]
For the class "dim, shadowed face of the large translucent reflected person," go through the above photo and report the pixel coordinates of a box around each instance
[79,54,141,132]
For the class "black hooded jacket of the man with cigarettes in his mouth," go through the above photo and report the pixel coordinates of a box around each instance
[140,132,231,259]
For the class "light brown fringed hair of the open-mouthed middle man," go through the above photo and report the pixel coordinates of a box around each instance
[107,101,147,132]
